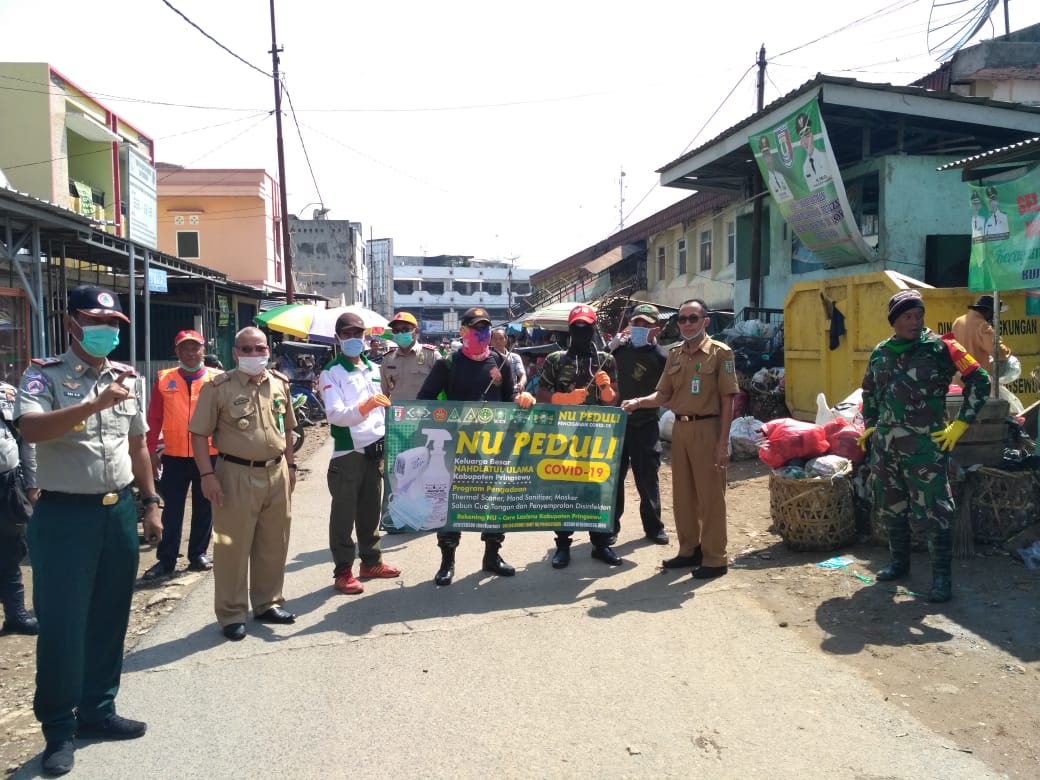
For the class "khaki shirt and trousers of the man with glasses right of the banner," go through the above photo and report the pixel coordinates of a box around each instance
[657,336,739,567]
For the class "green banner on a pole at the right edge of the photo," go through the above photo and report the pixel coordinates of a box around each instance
[968,166,1040,293]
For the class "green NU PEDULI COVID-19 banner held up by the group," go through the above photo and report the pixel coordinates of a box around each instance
[382,400,627,532]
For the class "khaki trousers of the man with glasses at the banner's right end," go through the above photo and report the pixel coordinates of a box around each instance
[672,417,728,566]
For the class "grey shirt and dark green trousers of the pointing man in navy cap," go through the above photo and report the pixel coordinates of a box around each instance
[15,349,148,743]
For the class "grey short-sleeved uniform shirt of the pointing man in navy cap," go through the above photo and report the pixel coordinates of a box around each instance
[15,349,148,495]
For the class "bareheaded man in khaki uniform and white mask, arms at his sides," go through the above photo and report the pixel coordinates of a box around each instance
[188,328,296,642]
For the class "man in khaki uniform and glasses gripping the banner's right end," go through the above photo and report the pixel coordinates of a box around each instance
[621,298,739,579]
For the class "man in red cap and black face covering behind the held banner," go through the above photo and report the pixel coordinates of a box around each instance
[537,304,622,569]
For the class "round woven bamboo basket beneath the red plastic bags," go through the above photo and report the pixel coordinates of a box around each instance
[770,474,856,551]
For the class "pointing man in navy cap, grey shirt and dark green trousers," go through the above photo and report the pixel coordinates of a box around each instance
[15,286,162,775]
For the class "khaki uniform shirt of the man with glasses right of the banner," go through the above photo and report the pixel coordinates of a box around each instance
[657,337,740,415]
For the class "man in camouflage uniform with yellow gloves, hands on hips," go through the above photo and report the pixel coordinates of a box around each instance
[860,290,989,602]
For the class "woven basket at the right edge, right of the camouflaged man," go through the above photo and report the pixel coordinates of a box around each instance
[968,467,1040,544]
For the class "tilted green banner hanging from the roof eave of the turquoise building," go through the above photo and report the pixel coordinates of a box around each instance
[748,97,877,268]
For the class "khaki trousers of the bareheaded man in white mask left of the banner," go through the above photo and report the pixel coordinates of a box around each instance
[213,458,290,626]
